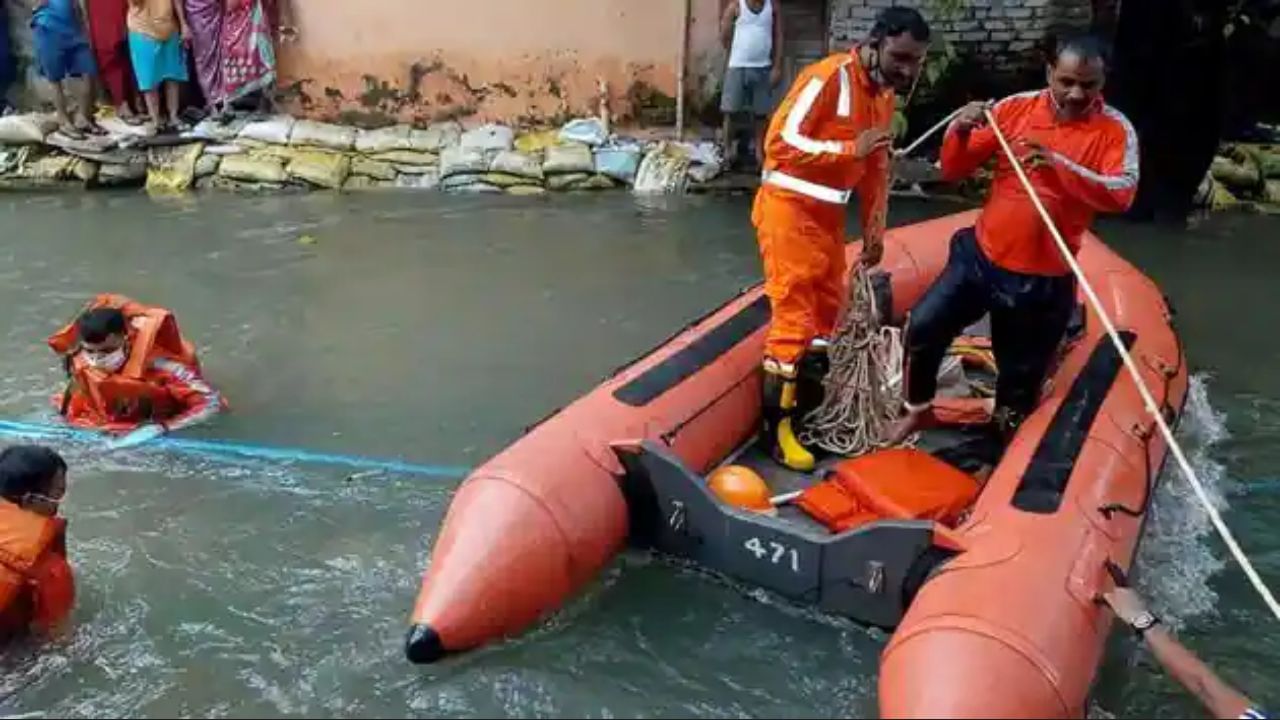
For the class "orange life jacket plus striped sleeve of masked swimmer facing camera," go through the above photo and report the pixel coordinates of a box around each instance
[49,295,225,432]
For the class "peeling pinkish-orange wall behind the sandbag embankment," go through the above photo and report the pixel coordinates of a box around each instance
[280,0,721,122]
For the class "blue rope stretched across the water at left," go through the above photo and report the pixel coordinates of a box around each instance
[0,420,471,479]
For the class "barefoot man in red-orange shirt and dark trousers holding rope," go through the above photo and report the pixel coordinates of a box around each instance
[891,36,1138,441]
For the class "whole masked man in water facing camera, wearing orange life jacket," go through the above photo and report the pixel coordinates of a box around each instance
[49,295,227,448]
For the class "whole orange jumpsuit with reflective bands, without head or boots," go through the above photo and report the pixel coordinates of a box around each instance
[751,47,895,370]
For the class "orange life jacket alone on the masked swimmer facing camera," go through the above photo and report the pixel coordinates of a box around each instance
[49,293,207,432]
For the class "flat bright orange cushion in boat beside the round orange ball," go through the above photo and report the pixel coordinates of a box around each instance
[796,448,980,533]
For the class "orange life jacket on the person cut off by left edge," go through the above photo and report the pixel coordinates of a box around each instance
[0,500,76,635]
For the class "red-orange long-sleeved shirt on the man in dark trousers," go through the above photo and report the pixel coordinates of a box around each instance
[942,90,1138,275]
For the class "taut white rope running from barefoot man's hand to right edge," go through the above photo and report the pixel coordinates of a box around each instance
[987,109,1280,620]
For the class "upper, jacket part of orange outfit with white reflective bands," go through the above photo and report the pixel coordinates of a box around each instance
[763,51,893,234]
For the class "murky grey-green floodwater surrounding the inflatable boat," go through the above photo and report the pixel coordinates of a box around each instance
[0,188,1280,717]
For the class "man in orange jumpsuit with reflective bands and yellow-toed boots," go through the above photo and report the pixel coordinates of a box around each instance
[751,8,929,471]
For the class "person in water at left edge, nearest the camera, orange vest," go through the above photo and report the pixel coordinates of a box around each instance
[0,445,76,639]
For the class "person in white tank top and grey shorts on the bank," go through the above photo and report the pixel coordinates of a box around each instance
[721,0,782,167]
